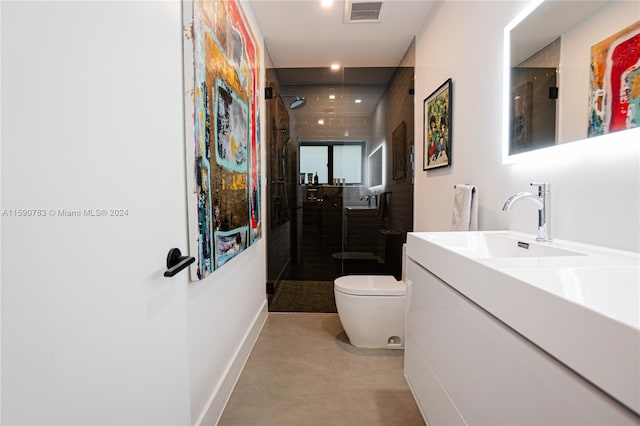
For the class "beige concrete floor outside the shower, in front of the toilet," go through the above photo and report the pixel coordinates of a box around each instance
[212,313,425,426]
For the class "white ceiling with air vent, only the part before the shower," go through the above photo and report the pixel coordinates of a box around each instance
[249,0,435,68]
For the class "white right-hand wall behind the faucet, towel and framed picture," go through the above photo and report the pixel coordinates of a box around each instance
[414,1,640,251]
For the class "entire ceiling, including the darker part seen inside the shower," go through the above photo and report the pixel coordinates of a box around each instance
[248,0,435,116]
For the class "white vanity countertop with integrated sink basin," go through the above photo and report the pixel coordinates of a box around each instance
[407,231,640,416]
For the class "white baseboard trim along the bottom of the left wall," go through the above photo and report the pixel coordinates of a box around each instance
[195,299,269,425]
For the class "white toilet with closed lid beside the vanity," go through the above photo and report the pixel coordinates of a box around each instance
[333,247,407,349]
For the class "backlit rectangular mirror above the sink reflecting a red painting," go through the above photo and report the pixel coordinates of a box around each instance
[503,0,640,158]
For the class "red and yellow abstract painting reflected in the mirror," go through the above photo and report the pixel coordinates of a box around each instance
[588,21,640,137]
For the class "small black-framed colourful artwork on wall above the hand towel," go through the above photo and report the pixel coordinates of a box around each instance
[423,79,452,170]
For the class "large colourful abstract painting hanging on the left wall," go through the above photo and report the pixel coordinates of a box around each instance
[185,0,262,279]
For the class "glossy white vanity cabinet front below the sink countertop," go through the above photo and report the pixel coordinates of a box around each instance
[405,258,640,426]
